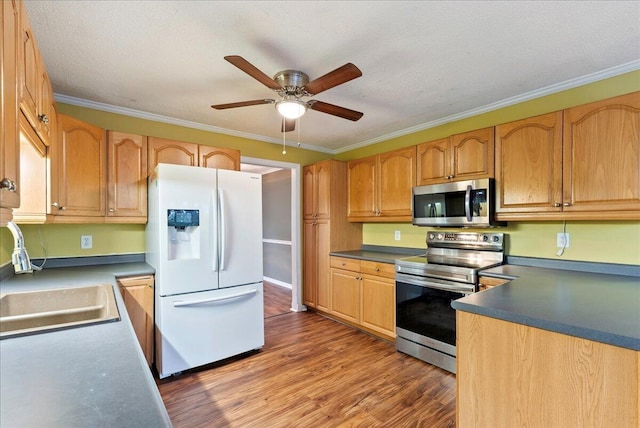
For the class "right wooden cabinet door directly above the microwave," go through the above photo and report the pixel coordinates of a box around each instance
[451,127,495,180]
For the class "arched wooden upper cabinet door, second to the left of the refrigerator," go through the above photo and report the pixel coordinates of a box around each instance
[51,114,107,217]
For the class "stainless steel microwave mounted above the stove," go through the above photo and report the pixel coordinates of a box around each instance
[411,178,506,227]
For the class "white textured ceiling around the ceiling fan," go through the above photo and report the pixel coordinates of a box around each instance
[26,0,640,152]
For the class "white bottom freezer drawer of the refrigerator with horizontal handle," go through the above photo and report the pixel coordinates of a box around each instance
[156,283,264,378]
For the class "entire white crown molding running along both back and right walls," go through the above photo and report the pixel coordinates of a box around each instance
[54,60,640,155]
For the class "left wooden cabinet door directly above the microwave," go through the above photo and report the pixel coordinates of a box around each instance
[416,138,453,186]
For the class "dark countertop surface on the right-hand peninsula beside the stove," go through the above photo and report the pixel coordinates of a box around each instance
[451,265,640,351]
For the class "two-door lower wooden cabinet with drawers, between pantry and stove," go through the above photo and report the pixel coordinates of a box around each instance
[329,257,396,340]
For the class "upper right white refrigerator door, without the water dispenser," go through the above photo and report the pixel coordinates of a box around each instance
[218,169,262,288]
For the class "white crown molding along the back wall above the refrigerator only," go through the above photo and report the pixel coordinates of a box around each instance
[54,93,335,154]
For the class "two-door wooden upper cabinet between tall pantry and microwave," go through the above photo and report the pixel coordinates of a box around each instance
[347,146,416,222]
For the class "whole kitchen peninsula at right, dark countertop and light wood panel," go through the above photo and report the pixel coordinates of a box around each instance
[452,265,640,427]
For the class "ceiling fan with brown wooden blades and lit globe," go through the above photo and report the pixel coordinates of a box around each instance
[211,55,363,132]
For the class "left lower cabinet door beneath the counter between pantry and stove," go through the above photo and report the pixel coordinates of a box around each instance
[331,269,360,324]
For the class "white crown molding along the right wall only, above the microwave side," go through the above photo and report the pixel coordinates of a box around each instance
[335,60,640,154]
